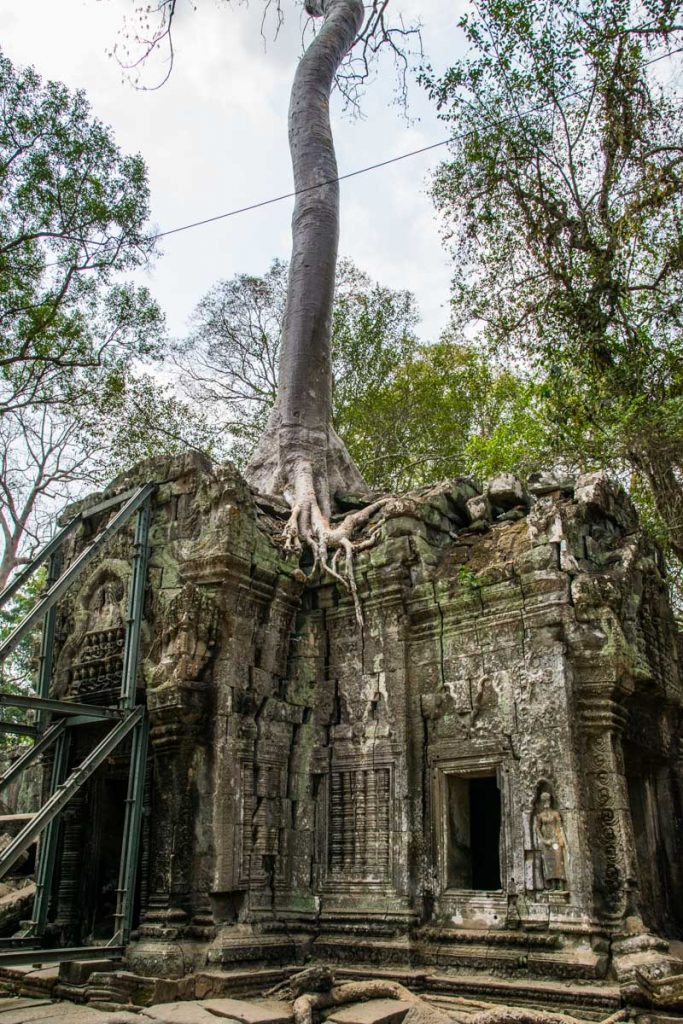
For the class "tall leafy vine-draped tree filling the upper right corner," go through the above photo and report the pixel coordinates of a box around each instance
[425,0,683,557]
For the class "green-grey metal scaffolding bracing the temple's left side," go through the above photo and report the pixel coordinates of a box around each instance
[0,483,156,966]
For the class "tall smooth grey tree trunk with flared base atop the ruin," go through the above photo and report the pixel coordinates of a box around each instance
[246,0,367,520]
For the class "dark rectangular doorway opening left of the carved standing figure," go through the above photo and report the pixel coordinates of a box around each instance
[446,773,502,892]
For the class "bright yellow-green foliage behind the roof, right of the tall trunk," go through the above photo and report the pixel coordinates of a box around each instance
[350,336,548,490]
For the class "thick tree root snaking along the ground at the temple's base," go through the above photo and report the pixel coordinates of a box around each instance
[268,966,628,1024]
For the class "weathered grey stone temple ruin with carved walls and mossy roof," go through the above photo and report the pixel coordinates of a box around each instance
[1,456,683,1019]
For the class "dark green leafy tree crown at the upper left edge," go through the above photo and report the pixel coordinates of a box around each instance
[0,48,163,412]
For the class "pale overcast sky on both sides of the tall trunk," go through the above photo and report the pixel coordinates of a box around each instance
[0,0,462,340]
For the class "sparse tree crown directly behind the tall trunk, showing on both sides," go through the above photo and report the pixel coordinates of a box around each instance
[176,260,418,473]
